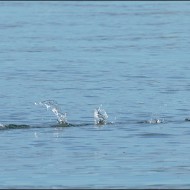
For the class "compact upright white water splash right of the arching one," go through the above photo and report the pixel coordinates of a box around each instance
[94,105,108,125]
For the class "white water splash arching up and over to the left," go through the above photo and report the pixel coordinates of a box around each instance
[35,100,68,125]
